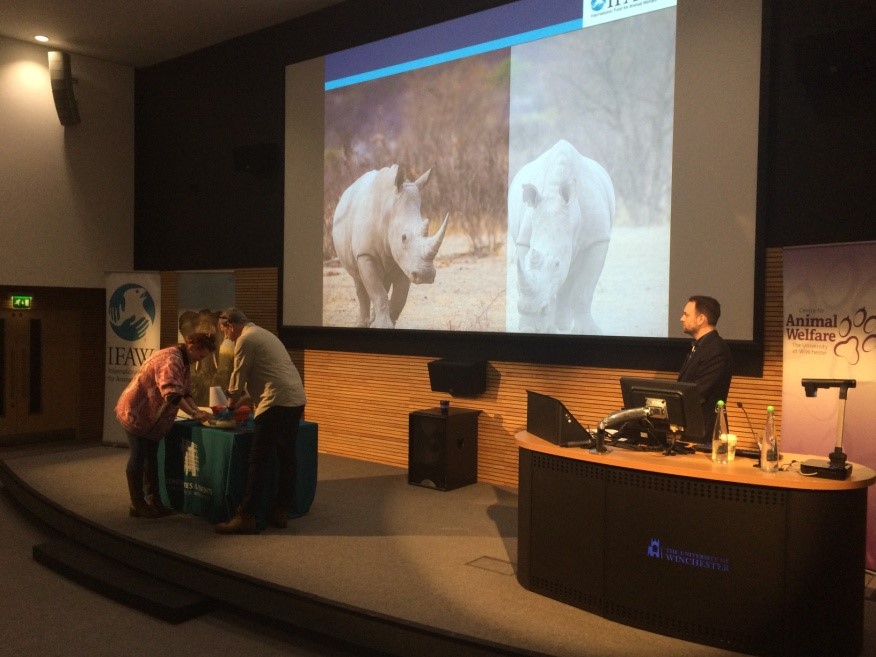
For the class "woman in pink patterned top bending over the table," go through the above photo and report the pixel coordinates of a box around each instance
[116,333,216,518]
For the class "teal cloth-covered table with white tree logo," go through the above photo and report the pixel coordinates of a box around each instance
[158,420,318,529]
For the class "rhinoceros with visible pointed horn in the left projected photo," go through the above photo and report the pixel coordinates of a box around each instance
[332,165,448,328]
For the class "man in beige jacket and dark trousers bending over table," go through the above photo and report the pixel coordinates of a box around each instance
[216,308,307,534]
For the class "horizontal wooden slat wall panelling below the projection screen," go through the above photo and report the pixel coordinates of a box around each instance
[162,249,782,486]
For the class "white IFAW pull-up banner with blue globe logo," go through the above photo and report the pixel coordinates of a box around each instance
[103,271,161,445]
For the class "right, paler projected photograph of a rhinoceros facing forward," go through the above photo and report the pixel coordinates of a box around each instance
[506,8,686,337]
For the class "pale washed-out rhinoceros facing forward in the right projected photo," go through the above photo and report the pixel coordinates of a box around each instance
[506,140,615,334]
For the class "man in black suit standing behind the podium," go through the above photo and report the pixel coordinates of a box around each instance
[678,295,733,438]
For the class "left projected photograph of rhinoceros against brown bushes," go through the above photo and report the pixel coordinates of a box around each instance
[323,49,509,332]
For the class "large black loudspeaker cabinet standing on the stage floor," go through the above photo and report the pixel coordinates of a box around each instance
[408,407,480,490]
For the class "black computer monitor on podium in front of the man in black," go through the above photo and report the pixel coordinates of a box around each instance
[620,376,710,443]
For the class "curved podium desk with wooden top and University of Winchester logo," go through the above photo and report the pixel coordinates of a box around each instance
[515,431,876,657]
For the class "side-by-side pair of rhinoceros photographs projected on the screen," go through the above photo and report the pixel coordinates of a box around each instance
[322,3,675,337]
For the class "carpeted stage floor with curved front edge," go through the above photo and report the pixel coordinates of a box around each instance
[3,446,876,657]
